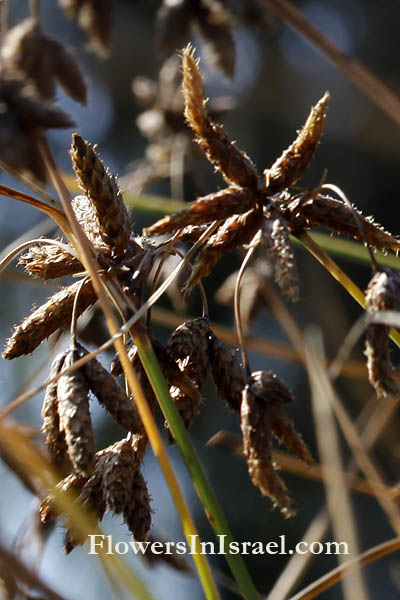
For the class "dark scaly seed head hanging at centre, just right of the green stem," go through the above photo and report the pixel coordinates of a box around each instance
[167,317,210,389]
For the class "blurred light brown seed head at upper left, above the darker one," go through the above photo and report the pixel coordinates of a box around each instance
[1,18,86,104]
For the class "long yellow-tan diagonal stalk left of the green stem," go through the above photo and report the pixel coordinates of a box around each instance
[40,140,219,600]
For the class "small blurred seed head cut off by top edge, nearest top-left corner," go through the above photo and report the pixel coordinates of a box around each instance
[58,0,113,56]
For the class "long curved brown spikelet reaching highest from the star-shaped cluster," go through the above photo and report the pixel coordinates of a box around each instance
[182,45,258,189]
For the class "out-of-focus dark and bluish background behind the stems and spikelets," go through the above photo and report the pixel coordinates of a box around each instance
[0,0,400,600]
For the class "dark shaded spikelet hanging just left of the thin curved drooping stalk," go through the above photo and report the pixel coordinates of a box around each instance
[209,333,245,413]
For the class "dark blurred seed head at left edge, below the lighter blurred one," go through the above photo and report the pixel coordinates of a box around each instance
[0,73,73,184]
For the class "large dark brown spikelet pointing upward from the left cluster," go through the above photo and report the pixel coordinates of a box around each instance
[70,133,131,255]
